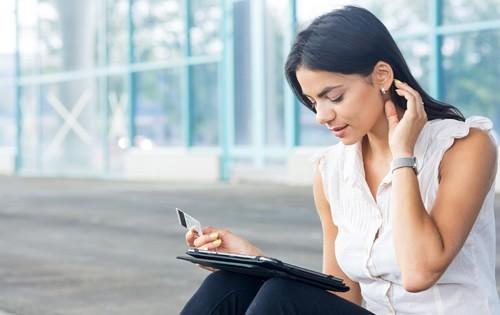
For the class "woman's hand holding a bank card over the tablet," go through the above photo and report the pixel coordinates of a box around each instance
[186,226,264,271]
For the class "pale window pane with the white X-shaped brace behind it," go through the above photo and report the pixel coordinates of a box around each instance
[20,79,103,175]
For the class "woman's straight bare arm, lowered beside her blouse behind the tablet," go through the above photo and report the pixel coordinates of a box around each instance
[313,163,361,305]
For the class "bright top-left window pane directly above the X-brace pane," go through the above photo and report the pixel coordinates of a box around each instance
[19,0,97,75]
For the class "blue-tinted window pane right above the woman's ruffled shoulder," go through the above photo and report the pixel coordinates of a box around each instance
[441,30,500,130]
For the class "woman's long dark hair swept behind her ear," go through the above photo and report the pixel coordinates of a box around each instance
[285,6,465,121]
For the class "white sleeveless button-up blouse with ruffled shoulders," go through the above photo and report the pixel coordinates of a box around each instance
[312,116,500,315]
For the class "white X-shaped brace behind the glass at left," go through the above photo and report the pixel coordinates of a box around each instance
[47,90,92,150]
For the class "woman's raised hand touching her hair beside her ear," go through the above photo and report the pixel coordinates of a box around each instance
[385,79,427,158]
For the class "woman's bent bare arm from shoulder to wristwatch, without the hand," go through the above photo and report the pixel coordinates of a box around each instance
[391,128,497,292]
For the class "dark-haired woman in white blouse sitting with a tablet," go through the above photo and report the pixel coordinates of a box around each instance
[179,6,500,314]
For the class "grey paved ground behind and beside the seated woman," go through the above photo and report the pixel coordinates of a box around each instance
[0,177,500,315]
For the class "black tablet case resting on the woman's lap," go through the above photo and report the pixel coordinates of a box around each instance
[176,248,349,292]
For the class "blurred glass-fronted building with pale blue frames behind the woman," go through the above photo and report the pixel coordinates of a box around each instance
[0,0,500,182]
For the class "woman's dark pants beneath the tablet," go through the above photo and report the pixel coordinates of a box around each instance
[181,270,372,315]
